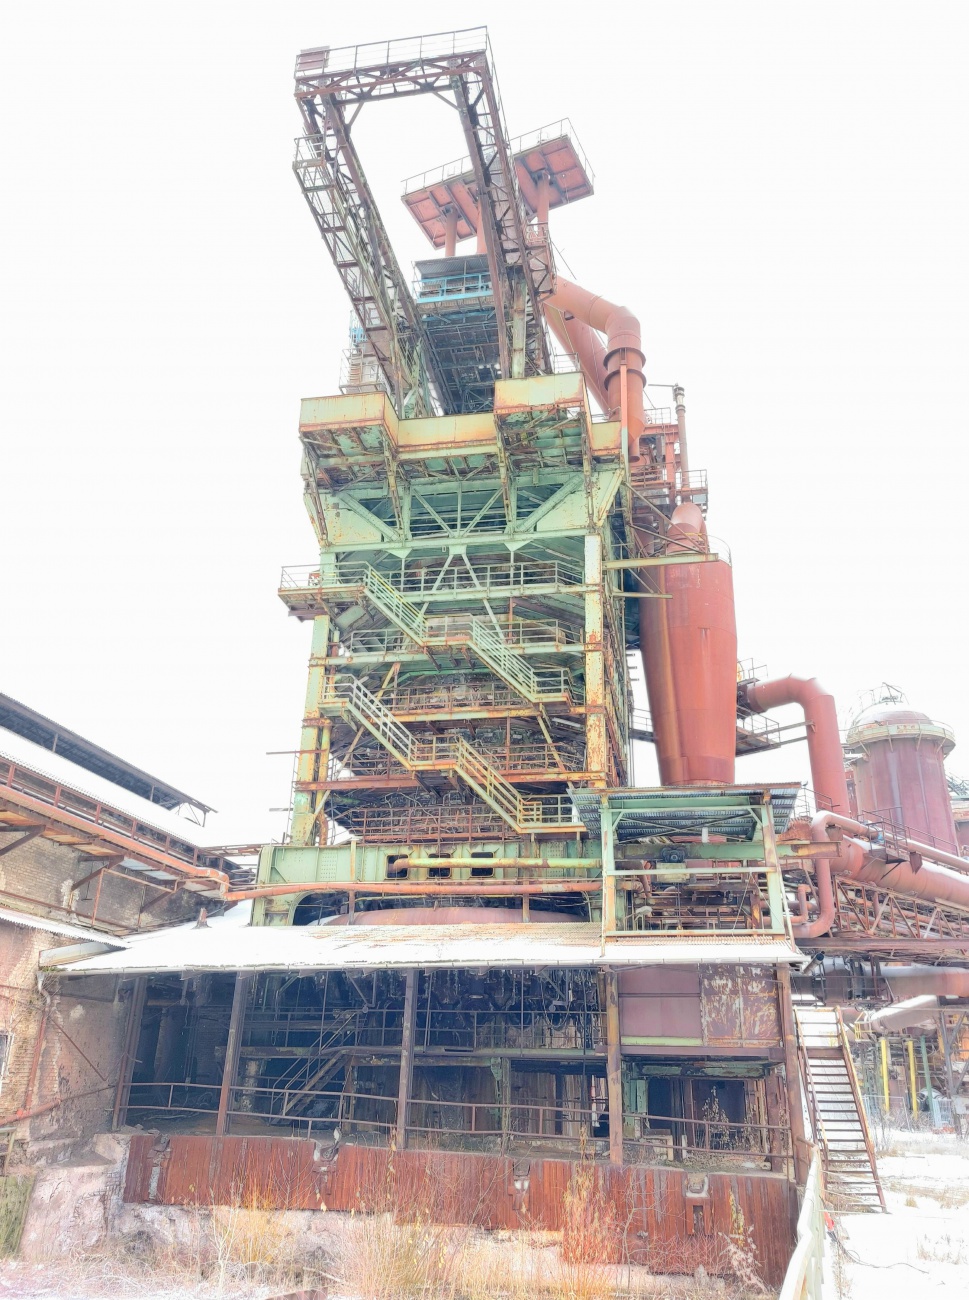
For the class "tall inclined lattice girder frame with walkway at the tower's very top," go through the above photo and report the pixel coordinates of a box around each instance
[295,29,554,415]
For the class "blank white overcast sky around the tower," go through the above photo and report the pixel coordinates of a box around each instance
[0,0,969,842]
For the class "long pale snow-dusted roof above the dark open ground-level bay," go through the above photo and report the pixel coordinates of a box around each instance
[45,923,805,975]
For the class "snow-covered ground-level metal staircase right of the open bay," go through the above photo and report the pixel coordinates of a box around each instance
[795,1005,886,1213]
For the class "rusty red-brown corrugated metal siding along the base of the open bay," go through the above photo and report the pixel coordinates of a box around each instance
[125,1134,797,1286]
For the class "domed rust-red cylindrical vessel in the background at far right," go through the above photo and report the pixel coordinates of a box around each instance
[847,705,957,853]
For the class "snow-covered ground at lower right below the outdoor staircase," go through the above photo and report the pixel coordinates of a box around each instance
[825,1131,969,1300]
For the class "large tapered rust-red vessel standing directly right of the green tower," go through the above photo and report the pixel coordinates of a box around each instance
[639,504,737,785]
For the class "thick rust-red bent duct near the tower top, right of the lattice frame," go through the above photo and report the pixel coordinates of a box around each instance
[545,276,646,467]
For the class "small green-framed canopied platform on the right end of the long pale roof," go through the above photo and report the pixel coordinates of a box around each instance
[571,783,801,944]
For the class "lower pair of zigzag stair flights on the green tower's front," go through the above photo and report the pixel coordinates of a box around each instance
[320,676,577,833]
